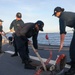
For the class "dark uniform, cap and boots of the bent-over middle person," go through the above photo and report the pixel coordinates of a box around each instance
[16,21,44,69]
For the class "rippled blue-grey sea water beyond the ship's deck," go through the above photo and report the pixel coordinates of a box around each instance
[3,33,73,46]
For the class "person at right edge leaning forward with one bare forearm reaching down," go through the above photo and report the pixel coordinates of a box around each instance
[53,7,75,75]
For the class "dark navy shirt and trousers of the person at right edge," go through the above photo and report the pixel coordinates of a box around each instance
[59,12,75,64]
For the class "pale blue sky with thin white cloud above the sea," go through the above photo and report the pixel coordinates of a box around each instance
[0,0,75,33]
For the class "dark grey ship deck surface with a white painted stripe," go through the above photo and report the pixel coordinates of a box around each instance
[0,44,70,75]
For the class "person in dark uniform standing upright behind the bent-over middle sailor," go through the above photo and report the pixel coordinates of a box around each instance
[10,12,24,57]
